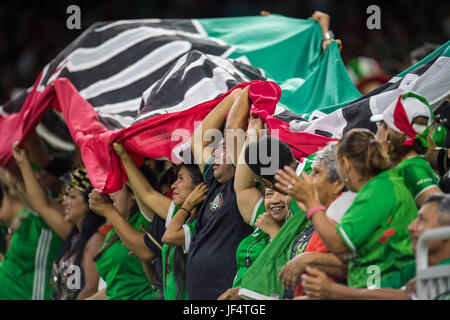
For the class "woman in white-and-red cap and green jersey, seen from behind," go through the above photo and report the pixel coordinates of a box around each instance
[371,92,442,207]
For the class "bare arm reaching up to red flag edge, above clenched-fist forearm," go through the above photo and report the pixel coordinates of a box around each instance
[113,142,172,220]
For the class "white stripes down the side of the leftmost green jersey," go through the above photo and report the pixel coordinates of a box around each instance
[32,229,51,300]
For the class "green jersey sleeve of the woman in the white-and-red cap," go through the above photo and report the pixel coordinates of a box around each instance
[395,155,439,200]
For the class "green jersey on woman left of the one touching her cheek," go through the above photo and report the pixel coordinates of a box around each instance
[96,212,159,300]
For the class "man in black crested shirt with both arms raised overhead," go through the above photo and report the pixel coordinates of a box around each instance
[186,88,253,300]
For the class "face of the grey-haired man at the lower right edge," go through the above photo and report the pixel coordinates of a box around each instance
[408,202,442,253]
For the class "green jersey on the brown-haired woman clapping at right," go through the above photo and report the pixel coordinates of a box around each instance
[336,169,417,288]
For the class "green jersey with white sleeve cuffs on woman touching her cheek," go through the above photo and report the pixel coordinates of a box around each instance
[161,202,196,300]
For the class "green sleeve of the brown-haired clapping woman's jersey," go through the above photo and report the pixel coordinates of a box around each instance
[336,178,395,252]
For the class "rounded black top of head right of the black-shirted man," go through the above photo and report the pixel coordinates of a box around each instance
[245,136,295,180]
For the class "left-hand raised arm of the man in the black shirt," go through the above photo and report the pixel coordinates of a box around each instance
[191,89,242,173]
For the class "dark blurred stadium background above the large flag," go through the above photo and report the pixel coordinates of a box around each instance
[0,0,450,103]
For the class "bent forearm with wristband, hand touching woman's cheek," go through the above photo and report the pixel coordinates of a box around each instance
[162,183,208,249]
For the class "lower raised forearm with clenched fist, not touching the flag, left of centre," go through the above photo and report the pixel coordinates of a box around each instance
[89,190,153,260]
